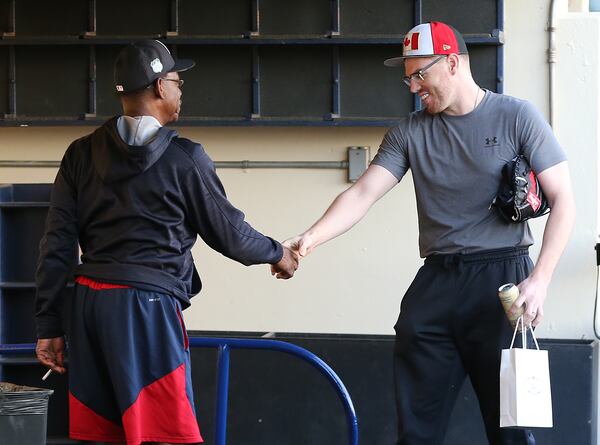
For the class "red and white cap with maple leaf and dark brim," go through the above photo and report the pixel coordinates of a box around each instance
[383,22,468,66]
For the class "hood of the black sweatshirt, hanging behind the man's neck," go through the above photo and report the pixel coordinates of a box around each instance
[92,117,177,183]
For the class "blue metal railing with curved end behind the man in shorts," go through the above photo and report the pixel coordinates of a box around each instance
[0,337,358,445]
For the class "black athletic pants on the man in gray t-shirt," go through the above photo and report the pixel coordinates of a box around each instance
[394,248,535,445]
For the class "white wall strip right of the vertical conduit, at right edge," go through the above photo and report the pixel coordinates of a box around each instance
[551,13,600,338]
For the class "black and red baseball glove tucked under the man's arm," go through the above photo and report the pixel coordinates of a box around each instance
[490,155,550,223]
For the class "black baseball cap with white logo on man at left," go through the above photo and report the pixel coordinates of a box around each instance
[114,40,196,93]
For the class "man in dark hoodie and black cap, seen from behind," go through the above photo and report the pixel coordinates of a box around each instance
[36,40,298,445]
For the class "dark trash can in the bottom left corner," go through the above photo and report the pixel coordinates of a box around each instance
[0,382,54,445]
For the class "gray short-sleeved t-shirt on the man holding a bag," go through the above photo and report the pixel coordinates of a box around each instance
[372,91,566,257]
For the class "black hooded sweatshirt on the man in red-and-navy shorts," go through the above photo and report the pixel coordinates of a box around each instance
[36,117,283,338]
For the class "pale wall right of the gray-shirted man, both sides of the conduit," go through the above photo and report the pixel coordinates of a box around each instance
[505,0,600,338]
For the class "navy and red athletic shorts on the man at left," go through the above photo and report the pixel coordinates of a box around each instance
[69,277,202,445]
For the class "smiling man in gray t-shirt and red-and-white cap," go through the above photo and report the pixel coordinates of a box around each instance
[284,22,575,445]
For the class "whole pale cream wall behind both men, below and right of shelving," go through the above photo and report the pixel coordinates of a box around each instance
[0,0,599,338]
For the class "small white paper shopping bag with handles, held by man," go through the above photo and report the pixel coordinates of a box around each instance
[500,318,552,428]
